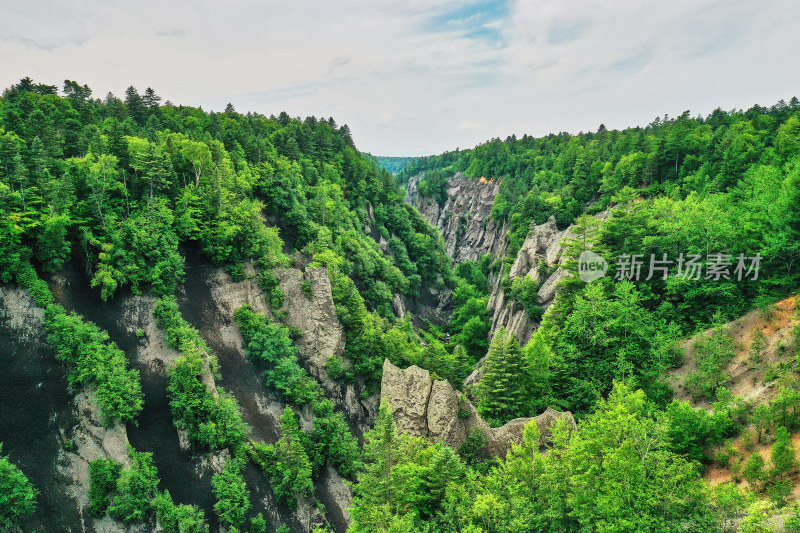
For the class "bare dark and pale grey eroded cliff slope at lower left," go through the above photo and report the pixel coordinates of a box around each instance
[0,250,366,533]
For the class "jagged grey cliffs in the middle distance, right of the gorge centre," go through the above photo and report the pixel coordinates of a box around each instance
[406,172,571,343]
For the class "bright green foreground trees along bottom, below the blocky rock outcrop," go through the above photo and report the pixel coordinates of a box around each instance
[351,384,720,533]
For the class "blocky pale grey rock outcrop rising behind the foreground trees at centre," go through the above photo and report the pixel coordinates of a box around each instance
[381,360,575,457]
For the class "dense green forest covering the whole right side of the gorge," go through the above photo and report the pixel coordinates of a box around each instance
[344,98,800,532]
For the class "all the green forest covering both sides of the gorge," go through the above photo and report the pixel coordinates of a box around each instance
[0,78,800,533]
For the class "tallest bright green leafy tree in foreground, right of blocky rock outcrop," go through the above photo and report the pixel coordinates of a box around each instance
[566,386,708,531]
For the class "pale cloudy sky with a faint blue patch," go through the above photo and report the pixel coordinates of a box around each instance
[0,0,800,156]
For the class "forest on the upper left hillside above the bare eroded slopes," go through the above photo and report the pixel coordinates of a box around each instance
[0,78,452,394]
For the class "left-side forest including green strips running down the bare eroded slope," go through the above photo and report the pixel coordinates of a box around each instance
[0,78,455,531]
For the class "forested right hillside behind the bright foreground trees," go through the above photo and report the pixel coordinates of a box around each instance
[398,98,800,419]
